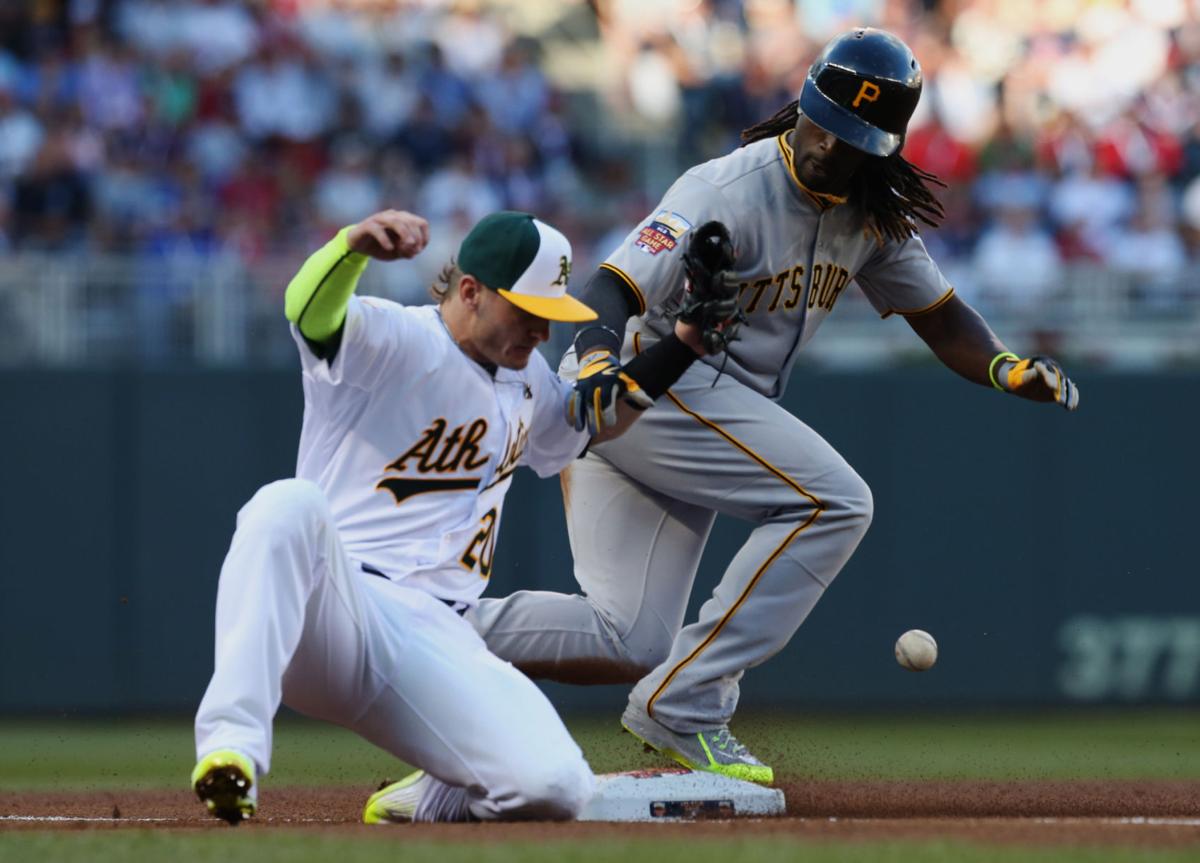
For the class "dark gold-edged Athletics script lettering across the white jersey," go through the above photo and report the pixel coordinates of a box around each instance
[376,416,529,504]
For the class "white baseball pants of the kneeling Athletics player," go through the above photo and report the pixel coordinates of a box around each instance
[196,479,593,819]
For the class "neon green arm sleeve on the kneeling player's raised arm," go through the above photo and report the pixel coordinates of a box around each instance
[283,227,371,344]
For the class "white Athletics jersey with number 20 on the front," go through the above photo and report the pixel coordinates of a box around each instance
[292,296,587,605]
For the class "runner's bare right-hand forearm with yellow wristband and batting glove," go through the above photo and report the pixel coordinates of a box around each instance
[907,296,1079,410]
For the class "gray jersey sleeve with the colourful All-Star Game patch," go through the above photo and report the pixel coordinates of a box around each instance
[600,173,738,314]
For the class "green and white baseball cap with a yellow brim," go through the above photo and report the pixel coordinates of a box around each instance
[458,210,596,322]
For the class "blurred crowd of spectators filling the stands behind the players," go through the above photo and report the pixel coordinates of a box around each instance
[0,0,1200,310]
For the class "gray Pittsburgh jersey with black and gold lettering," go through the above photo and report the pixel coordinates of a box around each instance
[602,136,953,398]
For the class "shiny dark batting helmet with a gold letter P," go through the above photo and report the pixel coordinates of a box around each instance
[800,28,922,156]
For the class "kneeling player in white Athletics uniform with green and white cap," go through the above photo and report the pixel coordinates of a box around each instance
[192,210,696,823]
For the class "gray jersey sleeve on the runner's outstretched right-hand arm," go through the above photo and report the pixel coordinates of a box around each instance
[854,236,954,318]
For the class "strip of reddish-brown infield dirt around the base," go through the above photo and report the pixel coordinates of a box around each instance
[0,781,1200,847]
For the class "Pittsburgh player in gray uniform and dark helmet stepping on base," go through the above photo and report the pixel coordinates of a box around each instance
[470,29,1079,783]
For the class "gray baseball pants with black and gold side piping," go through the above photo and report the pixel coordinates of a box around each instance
[469,333,871,733]
